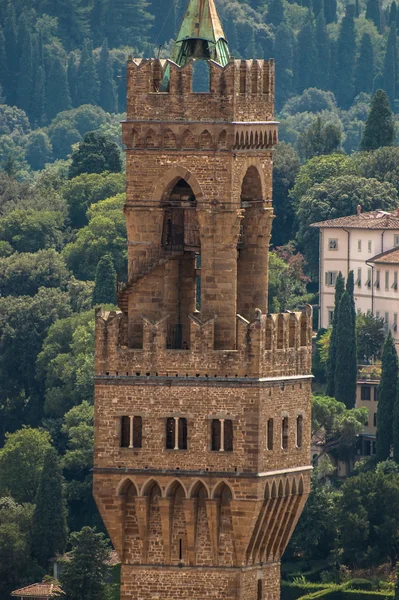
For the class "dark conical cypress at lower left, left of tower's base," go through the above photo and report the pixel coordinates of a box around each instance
[32,448,67,568]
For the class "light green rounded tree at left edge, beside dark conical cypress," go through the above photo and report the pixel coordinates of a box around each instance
[0,427,51,502]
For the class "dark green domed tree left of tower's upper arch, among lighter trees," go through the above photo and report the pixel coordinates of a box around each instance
[69,131,122,179]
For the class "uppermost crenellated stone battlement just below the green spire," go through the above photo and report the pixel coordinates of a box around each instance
[127,59,274,123]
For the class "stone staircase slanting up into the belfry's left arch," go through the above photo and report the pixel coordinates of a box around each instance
[117,245,183,314]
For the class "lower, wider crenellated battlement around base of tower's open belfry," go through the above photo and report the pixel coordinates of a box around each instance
[96,306,312,378]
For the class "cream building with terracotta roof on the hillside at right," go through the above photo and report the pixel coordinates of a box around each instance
[312,210,399,346]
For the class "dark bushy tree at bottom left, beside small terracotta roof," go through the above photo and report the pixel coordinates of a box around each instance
[60,527,110,600]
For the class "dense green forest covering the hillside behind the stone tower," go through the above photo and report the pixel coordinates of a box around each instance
[0,0,399,600]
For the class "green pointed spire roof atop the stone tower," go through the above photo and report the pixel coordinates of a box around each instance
[172,0,230,66]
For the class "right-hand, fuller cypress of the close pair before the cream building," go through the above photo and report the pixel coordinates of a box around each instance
[334,292,357,408]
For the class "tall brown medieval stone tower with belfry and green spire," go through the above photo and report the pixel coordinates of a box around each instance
[94,0,312,600]
